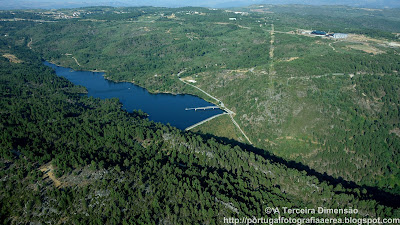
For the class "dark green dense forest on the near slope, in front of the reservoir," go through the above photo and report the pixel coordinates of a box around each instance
[0,37,400,224]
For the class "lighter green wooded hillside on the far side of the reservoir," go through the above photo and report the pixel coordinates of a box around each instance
[7,6,400,194]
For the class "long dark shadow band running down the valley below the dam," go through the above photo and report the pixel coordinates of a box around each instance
[195,132,400,208]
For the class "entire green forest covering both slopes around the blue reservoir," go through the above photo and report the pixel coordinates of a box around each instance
[0,6,400,224]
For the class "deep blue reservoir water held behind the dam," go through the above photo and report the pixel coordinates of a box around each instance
[44,62,224,130]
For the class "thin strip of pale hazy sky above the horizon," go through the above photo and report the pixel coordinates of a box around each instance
[0,0,400,9]
